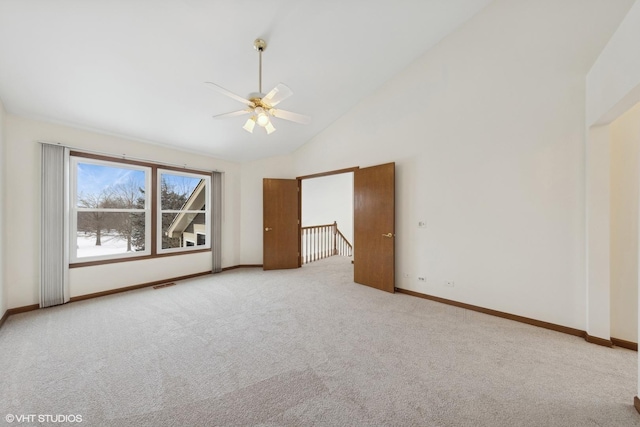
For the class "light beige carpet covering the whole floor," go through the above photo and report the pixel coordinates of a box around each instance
[0,257,640,427]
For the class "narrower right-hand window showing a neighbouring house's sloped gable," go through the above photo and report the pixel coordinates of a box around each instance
[158,169,211,253]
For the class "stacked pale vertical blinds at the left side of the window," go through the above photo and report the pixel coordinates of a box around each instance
[40,143,69,307]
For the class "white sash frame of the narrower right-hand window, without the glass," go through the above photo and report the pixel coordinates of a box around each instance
[156,167,211,255]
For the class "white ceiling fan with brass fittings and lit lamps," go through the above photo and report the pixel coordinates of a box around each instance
[205,39,311,134]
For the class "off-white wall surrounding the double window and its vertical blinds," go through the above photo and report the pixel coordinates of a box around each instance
[2,114,240,308]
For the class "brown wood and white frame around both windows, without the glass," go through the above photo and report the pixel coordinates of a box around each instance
[69,150,212,268]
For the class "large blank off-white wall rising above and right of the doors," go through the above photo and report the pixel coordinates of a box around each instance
[284,0,631,329]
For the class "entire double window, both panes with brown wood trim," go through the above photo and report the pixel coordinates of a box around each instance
[69,151,215,266]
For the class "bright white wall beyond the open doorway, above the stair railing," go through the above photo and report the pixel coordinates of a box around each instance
[302,172,353,244]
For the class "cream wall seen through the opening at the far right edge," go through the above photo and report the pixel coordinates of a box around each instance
[610,103,640,342]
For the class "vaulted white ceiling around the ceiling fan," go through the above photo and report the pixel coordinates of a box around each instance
[0,0,490,161]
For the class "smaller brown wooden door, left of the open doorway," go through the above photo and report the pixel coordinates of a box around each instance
[262,178,300,270]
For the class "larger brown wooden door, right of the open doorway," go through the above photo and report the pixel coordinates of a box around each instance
[353,163,395,292]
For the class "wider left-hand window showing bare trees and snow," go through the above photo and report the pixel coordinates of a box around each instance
[70,157,151,263]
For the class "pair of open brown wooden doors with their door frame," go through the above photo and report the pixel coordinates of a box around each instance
[262,162,395,293]
